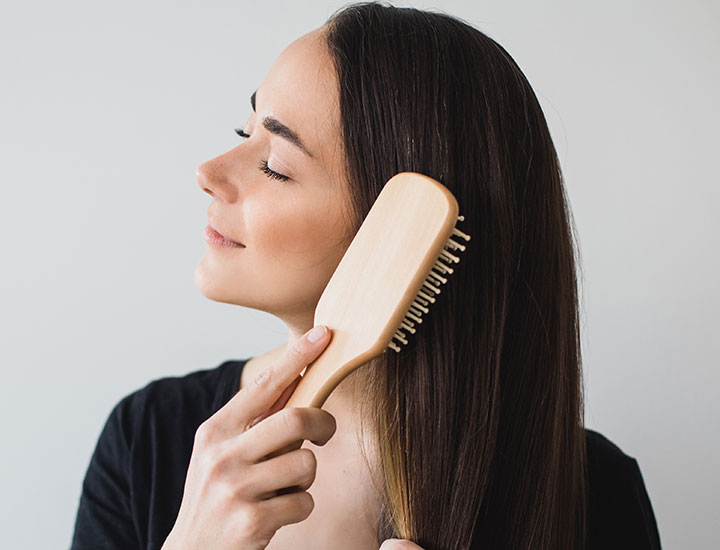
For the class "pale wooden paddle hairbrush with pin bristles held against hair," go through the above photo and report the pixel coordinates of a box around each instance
[283,172,470,408]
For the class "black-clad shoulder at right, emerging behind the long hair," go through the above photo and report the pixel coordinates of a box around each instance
[586,430,660,549]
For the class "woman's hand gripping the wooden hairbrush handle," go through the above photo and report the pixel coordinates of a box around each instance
[163,328,336,550]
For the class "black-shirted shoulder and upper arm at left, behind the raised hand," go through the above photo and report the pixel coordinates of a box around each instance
[72,361,250,549]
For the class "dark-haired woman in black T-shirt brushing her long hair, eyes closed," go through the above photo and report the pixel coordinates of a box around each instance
[73,3,659,550]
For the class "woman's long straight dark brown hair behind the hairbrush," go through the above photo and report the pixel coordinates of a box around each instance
[326,3,586,550]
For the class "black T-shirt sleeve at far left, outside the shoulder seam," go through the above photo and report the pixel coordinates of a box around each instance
[71,396,140,550]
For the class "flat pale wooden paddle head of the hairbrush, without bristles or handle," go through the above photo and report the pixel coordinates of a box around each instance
[315,172,458,355]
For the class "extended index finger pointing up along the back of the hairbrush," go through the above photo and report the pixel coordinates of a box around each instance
[214,325,330,431]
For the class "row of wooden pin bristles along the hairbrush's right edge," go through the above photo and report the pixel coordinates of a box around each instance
[388,216,470,353]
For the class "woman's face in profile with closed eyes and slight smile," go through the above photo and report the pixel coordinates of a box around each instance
[195,29,352,330]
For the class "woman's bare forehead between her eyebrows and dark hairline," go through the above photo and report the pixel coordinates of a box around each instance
[256,29,340,162]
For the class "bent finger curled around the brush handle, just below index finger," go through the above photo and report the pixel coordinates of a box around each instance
[235,407,337,463]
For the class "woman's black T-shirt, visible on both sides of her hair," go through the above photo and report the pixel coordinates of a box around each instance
[72,360,660,550]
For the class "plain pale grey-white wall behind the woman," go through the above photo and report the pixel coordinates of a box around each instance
[0,0,720,550]
